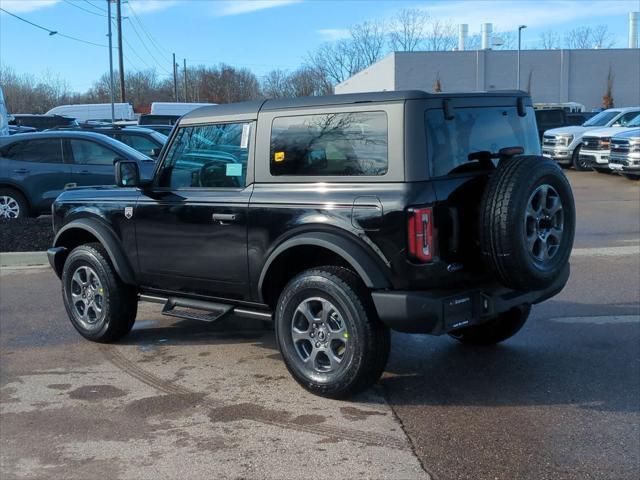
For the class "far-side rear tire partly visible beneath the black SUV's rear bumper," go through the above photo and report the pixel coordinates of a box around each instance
[449,305,531,345]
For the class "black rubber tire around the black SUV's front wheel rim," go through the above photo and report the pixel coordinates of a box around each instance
[62,243,138,343]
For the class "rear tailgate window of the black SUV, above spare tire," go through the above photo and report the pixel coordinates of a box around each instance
[426,107,540,177]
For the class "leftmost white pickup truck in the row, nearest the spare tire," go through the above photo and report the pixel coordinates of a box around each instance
[542,107,640,171]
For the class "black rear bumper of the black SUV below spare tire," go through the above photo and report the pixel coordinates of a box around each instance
[372,264,570,335]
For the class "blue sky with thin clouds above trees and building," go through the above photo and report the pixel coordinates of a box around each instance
[0,0,640,91]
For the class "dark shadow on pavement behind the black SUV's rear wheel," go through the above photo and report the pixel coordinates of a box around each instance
[382,302,640,412]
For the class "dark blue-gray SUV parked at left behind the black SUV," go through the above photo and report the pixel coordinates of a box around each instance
[0,132,155,218]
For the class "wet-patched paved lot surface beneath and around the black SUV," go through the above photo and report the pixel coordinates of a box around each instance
[0,173,640,480]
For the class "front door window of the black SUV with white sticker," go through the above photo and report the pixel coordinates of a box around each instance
[160,123,250,189]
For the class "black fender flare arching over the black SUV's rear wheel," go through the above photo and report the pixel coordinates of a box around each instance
[258,232,391,297]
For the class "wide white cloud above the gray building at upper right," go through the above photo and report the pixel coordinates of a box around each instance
[421,0,637,32]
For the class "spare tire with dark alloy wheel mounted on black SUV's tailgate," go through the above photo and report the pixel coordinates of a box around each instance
[480,155,576,290]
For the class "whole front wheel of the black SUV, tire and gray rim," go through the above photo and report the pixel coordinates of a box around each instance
[62,243,138,343]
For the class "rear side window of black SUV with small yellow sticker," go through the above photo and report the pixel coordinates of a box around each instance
[270,112,389,176]
